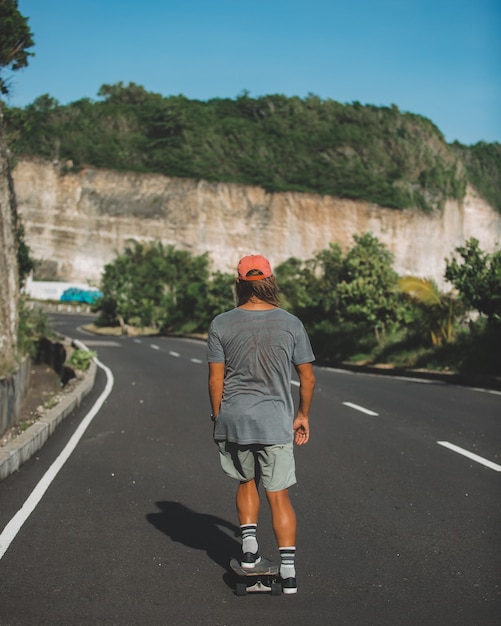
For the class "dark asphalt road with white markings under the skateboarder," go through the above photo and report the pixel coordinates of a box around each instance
[0,316,501,626]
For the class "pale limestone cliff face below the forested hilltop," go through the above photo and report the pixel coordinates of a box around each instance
[14,160,501,287]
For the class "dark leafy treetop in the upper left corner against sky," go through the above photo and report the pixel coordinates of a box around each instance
[0,0,35,95]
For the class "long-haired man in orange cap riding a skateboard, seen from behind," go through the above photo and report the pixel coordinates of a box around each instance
[208,255,315,594]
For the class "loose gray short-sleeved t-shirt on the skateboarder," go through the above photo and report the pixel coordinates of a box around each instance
[207,308,315,445]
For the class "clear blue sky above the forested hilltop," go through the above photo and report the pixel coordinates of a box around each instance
[4,0,501,144]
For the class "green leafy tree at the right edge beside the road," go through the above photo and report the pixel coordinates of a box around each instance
[445,237,501,324]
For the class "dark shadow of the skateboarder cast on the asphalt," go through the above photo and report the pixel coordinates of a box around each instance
[146,502,241,570]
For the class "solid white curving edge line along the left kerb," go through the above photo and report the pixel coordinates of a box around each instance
[0,342,114,559]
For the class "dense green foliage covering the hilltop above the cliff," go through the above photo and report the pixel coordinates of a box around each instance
[5,83,501,211]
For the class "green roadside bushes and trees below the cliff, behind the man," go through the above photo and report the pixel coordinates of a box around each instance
[95,233,501,376]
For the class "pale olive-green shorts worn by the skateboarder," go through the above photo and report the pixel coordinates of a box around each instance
[216,441,296,491]
